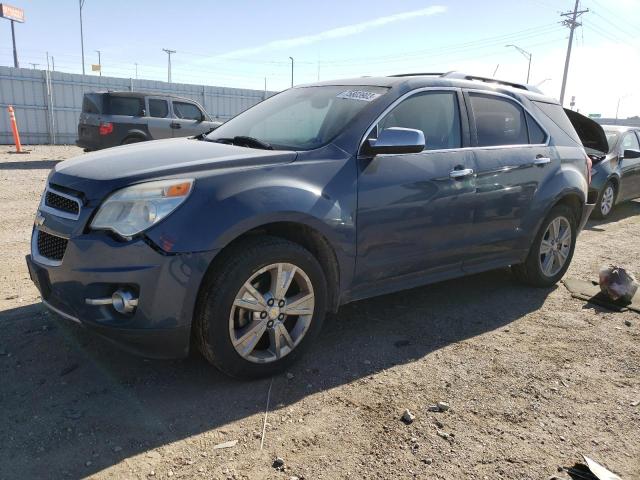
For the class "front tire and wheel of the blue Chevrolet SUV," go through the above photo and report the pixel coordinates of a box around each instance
[194,236,327,378]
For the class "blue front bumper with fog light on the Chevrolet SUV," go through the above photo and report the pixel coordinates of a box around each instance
[27,231,216,358]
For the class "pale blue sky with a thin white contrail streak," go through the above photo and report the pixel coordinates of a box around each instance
[0,0,640,118]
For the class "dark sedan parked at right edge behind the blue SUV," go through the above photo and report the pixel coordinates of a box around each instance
[587,125,640,219]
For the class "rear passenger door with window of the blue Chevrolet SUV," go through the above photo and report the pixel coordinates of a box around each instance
[463,90,560,272]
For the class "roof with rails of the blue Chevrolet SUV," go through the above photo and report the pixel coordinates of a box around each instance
[295,72,559,104]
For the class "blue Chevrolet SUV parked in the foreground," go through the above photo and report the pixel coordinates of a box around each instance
[27,73,606,377]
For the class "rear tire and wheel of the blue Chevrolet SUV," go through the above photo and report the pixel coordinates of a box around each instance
[511,205,578,288]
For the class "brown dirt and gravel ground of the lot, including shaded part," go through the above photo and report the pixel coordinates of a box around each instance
[0,147,640,480]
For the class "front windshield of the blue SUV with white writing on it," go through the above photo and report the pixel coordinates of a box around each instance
[206,86,388,150]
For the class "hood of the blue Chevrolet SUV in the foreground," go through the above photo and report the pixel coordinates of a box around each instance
[49,138,297,198]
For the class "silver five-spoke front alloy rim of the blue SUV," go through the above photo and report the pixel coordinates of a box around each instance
[229,263,315,363]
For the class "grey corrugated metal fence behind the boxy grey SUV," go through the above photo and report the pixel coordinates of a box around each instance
[0,66,273,145]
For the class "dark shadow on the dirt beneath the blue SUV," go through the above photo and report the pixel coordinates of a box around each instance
[0,270,552,478]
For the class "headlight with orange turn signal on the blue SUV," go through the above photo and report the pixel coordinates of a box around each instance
[91,179,193,237]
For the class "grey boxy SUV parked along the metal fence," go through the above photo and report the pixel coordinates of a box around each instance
[76,92,221,151]
